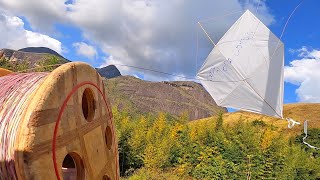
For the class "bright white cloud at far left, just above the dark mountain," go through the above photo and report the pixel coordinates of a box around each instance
[0,11,62,53]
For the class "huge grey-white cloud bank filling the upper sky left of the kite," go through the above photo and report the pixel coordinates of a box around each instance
[0,0,274,80]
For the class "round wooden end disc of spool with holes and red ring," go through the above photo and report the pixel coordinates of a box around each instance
[0,62,119,180]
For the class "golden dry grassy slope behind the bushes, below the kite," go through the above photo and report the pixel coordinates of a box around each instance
[192,103,320,136]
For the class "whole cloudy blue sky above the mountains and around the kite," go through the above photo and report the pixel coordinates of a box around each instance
[0,0,320,103]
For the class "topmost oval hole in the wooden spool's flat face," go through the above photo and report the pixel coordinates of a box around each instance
[82,88,96,122]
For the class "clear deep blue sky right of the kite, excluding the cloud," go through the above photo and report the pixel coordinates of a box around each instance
[267,0,320,103]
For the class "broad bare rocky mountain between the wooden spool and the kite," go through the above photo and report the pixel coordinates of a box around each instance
[105,76,227,120]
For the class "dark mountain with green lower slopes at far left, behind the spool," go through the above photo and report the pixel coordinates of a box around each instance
[0,47,70,71]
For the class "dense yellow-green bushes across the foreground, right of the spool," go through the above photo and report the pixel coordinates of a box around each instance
[113,108,320,179]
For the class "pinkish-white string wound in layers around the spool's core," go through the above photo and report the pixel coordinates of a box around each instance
[0,73,47,180]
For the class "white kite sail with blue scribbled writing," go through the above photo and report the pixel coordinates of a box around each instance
[197,10,284,118]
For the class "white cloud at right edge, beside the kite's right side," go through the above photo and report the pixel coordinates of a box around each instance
[284,47,320,102]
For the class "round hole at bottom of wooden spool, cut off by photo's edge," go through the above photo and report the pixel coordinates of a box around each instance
[62,153,85,180]
